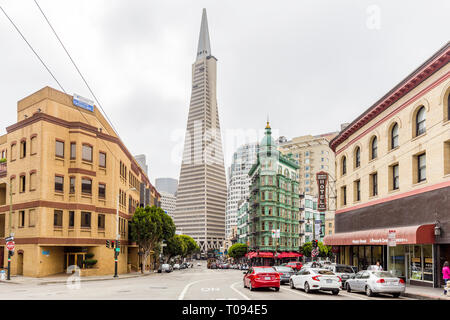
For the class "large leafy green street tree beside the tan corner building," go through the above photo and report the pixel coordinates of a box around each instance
[130,206,175,273]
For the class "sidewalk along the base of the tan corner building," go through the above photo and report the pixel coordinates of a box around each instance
[0,271,156,285]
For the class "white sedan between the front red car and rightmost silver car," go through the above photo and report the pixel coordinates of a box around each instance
[289,268,342,295]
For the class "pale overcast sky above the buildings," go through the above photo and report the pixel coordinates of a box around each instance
[0,0,450,182]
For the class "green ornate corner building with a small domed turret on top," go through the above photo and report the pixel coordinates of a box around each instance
[247,123,300,257]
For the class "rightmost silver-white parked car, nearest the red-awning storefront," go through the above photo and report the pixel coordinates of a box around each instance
[345,270,405,298]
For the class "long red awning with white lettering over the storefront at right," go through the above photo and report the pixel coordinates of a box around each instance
[323,224,434,246]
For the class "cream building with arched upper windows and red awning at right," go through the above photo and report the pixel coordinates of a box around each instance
[325,43,450,286]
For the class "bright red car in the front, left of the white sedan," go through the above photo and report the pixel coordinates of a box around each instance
[244,267,280,291]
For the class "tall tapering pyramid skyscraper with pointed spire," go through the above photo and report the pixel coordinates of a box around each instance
[174,9,227,253]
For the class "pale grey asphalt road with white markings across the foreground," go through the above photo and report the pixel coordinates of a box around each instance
[0,262,411,300]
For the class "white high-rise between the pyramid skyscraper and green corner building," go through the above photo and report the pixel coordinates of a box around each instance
[225,143,258,237]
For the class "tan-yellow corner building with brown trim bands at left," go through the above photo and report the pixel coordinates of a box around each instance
[0,87,158,277]
